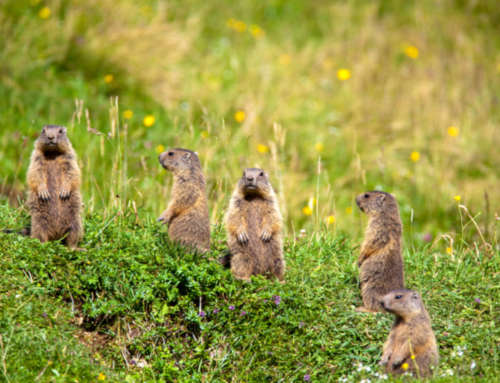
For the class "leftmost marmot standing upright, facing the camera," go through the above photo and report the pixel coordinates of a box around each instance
[27,125,83,249]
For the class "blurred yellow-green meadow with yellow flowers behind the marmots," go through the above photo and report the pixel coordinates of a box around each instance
[0,0,500,246]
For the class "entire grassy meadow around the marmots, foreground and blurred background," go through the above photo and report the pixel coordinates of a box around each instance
[0,0,500,383]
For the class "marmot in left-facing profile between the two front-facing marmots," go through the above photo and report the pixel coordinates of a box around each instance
[158,148,210,252]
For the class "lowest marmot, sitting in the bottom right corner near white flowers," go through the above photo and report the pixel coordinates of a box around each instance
[380,289,439,377]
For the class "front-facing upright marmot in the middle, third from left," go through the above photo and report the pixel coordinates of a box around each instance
[225,168,285,281]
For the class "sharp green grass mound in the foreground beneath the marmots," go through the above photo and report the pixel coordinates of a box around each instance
[0,205,500,382]
